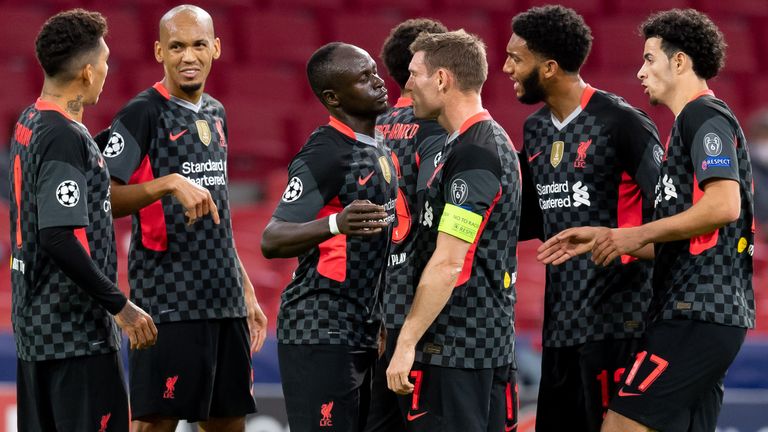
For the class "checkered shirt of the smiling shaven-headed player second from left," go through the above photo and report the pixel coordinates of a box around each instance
[104,84,246,322]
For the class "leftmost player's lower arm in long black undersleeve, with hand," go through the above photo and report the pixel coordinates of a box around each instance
[40,227,157,349]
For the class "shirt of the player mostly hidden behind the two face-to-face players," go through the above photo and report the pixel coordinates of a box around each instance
[376,98,447,329]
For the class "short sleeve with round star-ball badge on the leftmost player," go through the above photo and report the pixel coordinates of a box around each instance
[35,130,89,229]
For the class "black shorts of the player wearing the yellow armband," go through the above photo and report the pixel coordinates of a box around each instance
[398,362,518,432]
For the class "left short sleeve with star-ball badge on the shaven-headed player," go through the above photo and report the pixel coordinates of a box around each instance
[102,101,154,183]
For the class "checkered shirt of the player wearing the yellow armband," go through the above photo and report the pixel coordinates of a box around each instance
[414,111,521,369]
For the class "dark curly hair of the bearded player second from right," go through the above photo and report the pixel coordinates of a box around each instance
[512,5,592,73]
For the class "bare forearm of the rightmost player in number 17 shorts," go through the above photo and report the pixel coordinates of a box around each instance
[638,180,741,244]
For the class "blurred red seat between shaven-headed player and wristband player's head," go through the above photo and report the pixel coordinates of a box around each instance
[242,12,322,65]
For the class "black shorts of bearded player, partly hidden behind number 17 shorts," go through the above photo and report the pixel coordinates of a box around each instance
[536,339,640,432]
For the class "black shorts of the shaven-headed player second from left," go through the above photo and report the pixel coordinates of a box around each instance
[129,318,256,422]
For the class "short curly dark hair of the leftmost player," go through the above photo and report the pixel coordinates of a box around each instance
[35,9,107,81]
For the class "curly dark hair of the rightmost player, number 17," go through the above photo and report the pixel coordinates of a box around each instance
[640,9,728,79]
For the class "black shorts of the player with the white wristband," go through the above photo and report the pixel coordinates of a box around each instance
[277,343,376,432]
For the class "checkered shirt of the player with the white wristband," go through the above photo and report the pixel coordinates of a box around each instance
[273,120,398,348]
